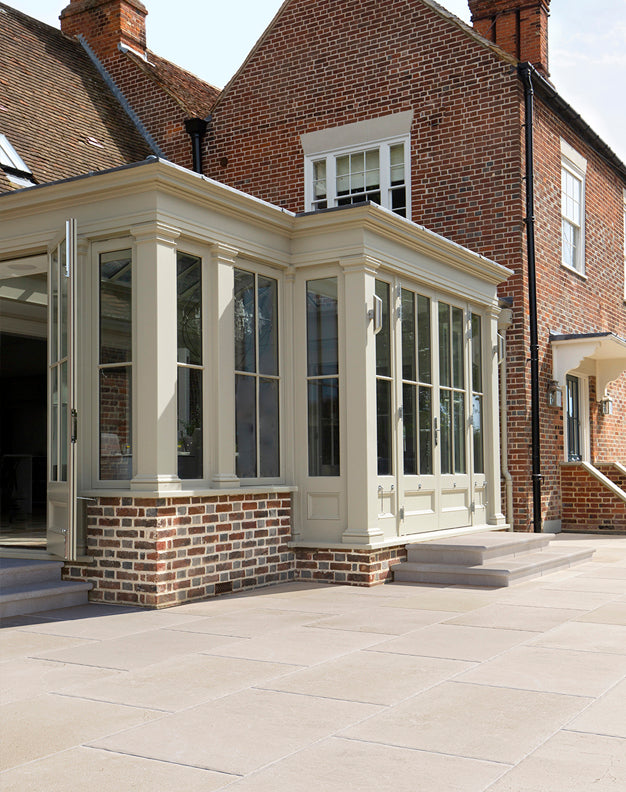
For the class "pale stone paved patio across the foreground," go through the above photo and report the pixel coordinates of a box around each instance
[0,534,626,792]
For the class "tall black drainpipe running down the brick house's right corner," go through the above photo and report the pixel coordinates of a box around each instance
[518,63,542,533]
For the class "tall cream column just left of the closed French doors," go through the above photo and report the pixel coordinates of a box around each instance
[340,256,383,544]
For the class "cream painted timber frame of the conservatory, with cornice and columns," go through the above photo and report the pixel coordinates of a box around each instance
[0,160,510,560]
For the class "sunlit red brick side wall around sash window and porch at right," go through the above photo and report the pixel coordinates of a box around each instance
[528,101,626,519]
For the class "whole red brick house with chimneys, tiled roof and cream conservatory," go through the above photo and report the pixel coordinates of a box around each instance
[0,0,626,607]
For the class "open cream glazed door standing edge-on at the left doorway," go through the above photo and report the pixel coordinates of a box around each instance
[47,220,77,559]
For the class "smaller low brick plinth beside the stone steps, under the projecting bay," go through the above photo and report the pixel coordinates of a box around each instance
[294,545,407,586]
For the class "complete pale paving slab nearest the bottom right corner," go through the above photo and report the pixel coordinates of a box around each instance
[340,682,591,764]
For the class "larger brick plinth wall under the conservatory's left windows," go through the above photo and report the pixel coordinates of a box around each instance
[63,493,294,608]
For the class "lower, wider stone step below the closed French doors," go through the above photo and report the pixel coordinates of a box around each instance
[394,549,594,588]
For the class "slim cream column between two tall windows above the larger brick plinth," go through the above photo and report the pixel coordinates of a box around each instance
[211,244,239,489]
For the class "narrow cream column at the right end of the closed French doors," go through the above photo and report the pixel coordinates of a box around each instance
[483,307,506,525]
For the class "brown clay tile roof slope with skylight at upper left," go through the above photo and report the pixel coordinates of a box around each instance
[0,3,152,192]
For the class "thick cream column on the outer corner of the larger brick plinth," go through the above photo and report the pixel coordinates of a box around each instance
[130,221,181,491]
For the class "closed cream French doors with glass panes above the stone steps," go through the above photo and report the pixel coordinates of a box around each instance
[376,280,486,534]
